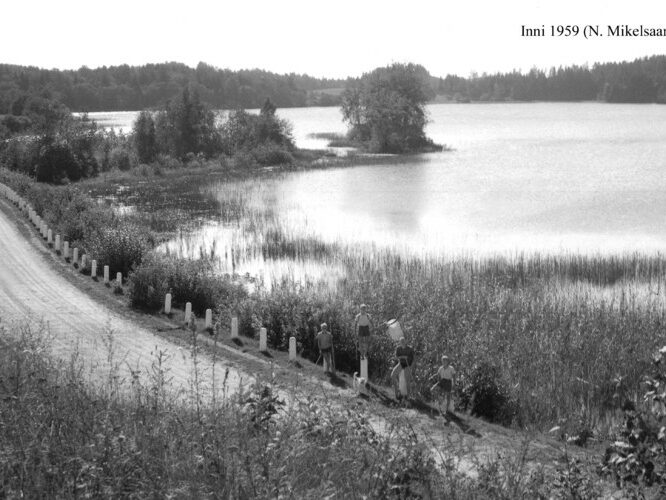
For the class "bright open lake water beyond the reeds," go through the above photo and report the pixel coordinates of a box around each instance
[90,103,666,278]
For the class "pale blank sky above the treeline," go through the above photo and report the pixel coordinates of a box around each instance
[5,0,666,78]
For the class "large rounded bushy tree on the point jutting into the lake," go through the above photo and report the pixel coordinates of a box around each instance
[342,64,441,153]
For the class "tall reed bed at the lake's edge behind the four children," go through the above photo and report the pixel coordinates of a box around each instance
[236,240,664,427]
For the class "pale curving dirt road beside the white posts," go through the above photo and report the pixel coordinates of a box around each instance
[0,200,252,398]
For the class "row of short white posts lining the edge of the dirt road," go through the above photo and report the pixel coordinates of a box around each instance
[0,183,368,380]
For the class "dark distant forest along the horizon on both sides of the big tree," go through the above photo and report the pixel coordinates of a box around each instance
[0,56,666,115]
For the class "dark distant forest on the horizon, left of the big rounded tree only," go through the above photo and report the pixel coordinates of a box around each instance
[0,62,345,115]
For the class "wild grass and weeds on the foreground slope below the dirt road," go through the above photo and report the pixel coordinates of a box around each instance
[0,318,596,499]
